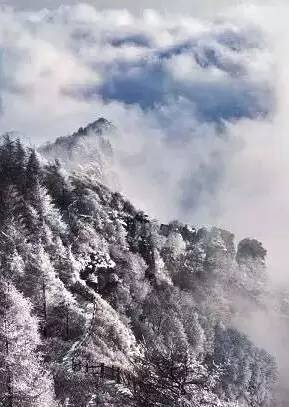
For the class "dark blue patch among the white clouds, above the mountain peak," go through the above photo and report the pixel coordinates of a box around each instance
[95,64,272,121]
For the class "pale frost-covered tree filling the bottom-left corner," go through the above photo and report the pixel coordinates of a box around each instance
[0,280,56,407]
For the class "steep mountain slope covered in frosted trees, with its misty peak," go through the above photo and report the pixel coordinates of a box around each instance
[0,126,277,407]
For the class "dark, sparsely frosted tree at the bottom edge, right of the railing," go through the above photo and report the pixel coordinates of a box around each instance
[132,344,226,407]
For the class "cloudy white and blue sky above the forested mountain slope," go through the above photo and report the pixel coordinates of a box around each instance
[0,0,289,286]
